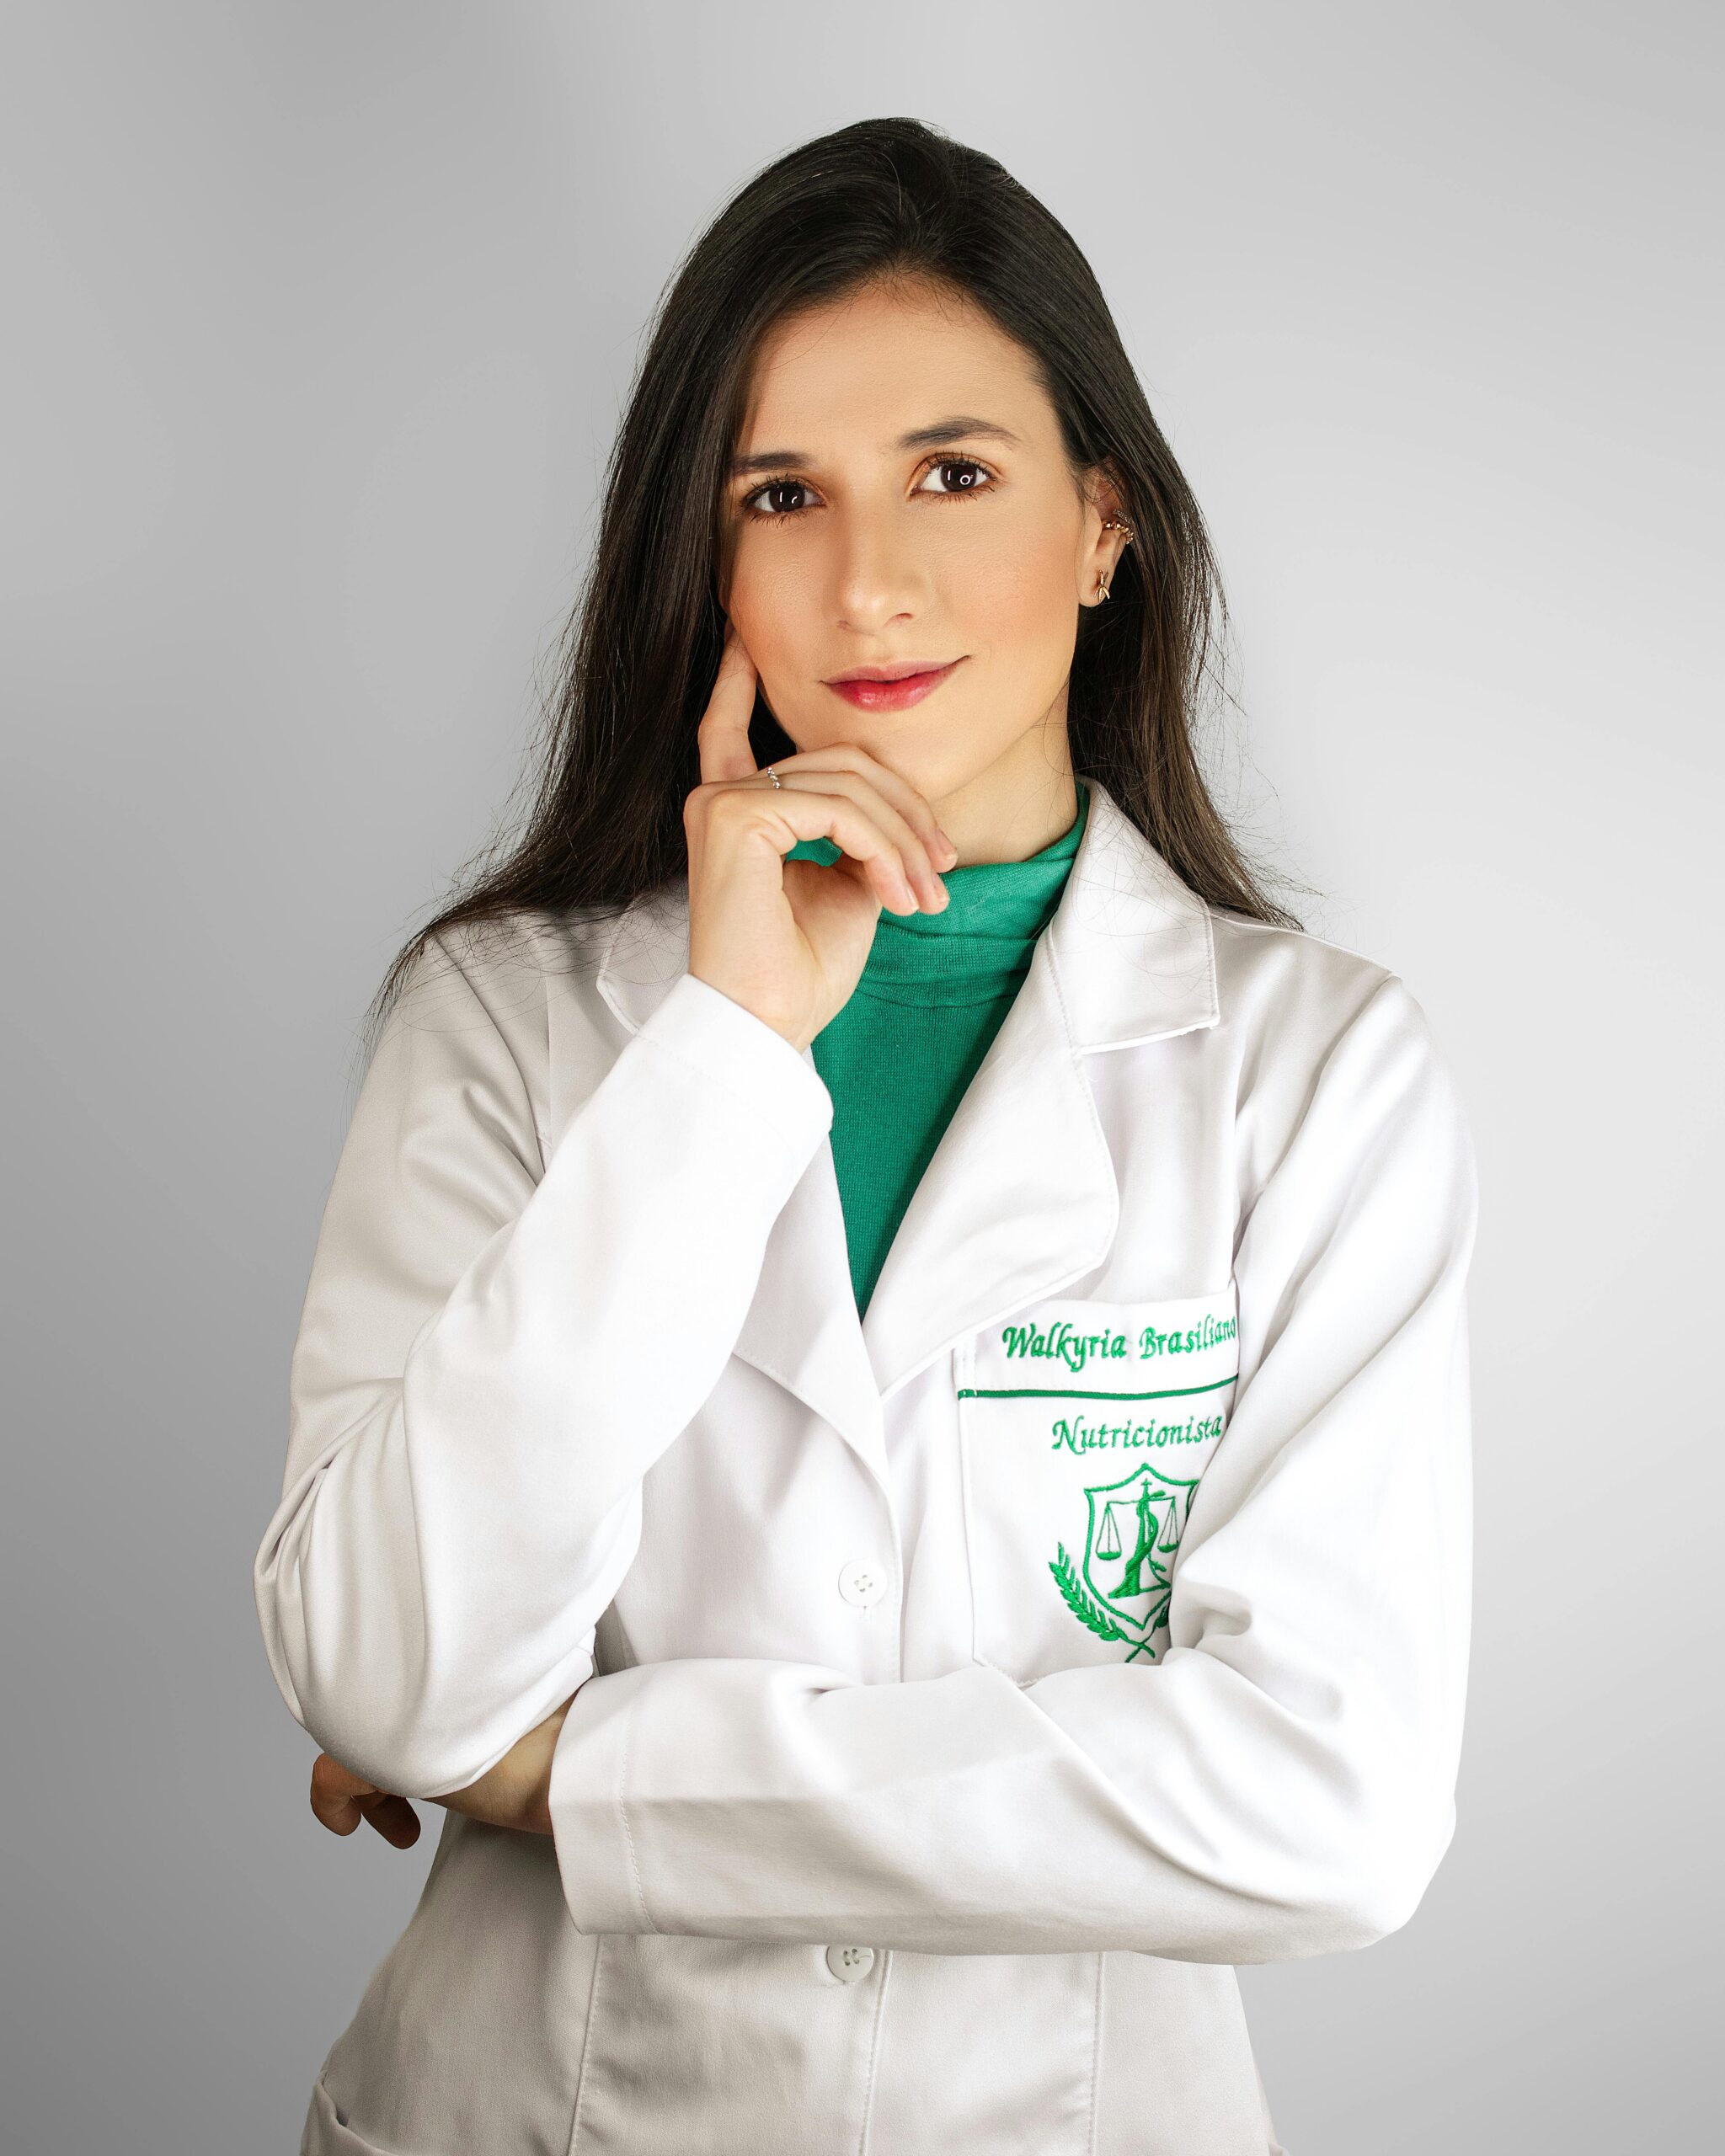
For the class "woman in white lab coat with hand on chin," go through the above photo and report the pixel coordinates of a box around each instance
[254,120,1477,2156]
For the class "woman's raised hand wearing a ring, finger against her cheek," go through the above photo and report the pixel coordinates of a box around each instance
[684,625,958,1048]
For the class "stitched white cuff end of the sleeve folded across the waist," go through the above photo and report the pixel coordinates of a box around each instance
[547,1667,658,1934]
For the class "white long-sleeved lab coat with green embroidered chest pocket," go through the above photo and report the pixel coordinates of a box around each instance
[254,781,1477,2156]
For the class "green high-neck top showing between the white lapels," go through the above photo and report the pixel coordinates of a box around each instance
[785,778,1089,1310]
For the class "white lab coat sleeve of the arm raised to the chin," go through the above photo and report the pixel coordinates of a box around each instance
[253,938,832,1796]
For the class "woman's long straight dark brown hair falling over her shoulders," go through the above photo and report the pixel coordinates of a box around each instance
[357,119,1300,1069]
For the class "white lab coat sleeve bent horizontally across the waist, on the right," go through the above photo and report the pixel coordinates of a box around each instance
[550,974,1477,1962]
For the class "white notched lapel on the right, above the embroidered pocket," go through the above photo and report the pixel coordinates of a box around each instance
[862,781,1218,1397]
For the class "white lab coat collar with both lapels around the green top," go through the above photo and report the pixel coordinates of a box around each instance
[600,778,1220,1492]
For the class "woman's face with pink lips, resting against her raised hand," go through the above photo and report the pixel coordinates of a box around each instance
[720,286,1121,860]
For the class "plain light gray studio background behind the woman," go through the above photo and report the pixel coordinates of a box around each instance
[0,0,1721,2156]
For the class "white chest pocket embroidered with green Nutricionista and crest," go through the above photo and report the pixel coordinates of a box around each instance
[958,1281,1240,1684]
